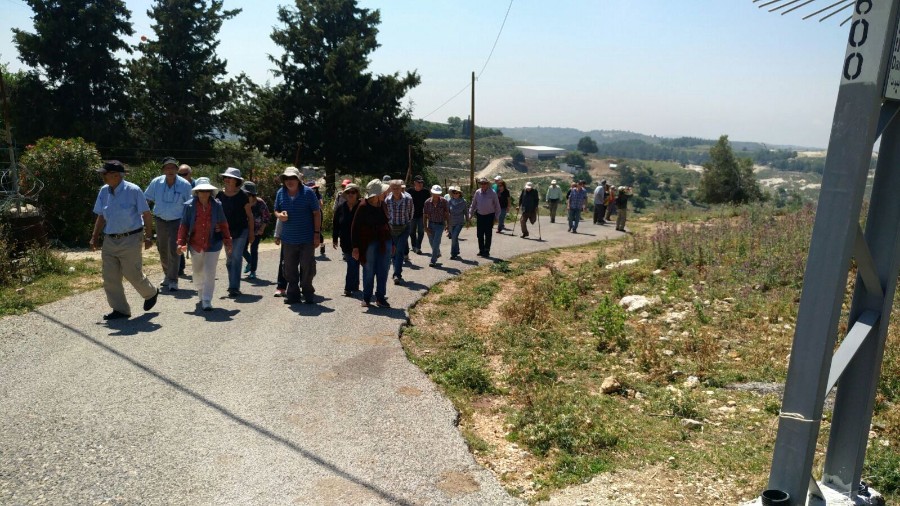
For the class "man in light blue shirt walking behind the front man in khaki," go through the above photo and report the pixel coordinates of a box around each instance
[144,157,193,292]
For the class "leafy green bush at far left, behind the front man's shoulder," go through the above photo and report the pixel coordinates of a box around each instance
[22,137,103,245]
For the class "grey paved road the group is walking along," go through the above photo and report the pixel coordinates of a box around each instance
[0,217,618,505]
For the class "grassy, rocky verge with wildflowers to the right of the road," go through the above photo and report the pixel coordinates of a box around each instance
[402,205,900,504]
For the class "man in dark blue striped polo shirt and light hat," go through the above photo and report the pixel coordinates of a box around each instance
[275,167,322,304]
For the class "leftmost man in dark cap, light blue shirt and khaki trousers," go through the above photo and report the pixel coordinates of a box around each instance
[90,160,159,320]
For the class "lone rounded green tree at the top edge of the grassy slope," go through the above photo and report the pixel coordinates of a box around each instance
[698,135,764,204]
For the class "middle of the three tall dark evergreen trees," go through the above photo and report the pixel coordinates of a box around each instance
[129,0,241,158]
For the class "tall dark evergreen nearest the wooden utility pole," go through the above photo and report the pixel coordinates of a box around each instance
[263,0,433,194]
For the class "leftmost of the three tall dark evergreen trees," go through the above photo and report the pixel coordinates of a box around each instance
[13,0,134,146]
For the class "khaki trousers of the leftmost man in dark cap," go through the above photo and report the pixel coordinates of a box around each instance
[101,232,156,315]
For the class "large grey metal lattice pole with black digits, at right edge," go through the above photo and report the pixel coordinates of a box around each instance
[761,0,900,506]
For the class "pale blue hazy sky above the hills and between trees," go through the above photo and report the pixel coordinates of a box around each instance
[0,0,848,147]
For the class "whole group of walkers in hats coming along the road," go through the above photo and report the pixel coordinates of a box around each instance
[90,158,630,320]
